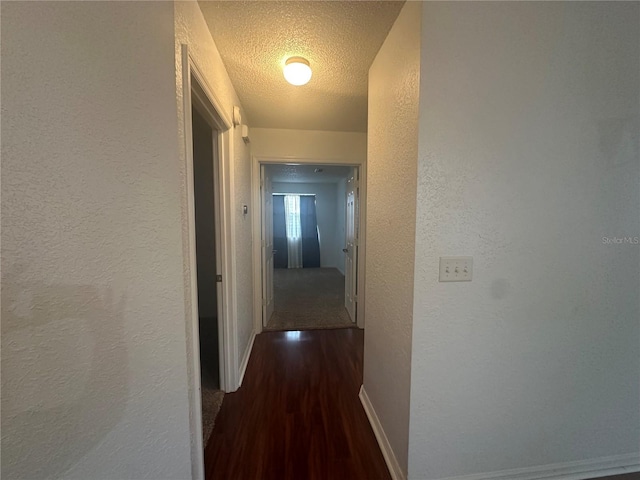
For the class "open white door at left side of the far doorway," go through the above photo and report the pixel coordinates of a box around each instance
[260,165,274,326]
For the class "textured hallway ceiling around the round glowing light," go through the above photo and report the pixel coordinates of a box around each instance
[199,0,404,132]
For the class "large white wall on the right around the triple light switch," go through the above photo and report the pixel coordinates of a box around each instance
[410,2,640,479]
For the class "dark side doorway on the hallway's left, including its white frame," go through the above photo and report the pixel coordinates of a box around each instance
[180,45,240,478]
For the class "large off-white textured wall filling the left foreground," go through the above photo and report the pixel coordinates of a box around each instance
[2,2,191,479]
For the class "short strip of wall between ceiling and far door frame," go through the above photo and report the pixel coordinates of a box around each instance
[250,128,367,163]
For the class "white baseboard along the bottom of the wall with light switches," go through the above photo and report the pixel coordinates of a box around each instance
[430,453,640,480]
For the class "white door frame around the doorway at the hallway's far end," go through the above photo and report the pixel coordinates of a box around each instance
[251,155,367,333]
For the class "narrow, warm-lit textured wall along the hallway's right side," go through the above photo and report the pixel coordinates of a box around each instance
[363,2,421,472]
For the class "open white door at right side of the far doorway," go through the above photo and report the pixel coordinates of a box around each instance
[343,168,358,322]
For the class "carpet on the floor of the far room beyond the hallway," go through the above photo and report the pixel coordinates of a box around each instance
[266,268,355,330]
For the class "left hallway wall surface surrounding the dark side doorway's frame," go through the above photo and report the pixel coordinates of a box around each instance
[174,2,253,472]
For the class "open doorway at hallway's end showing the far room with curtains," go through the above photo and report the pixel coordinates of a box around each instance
[255,164,362,330]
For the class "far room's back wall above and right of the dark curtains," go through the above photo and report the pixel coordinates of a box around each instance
[273,182,342,268]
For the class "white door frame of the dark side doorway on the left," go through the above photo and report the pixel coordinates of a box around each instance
[181,44,239,478]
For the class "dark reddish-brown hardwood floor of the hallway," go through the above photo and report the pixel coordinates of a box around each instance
[205,329,391,480]
